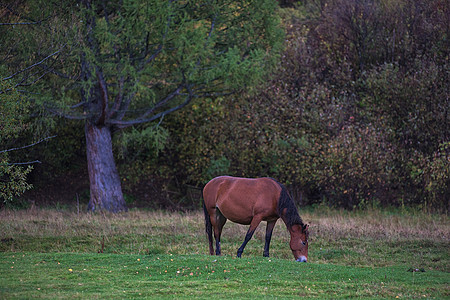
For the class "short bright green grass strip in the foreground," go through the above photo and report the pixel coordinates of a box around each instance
[0,253,449,299]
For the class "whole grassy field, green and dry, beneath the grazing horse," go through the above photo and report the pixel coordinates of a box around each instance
[0,208,450,299]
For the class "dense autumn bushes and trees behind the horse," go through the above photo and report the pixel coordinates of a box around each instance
[7,0,450,210]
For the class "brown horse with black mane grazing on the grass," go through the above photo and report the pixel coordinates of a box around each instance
[203,176,309,262]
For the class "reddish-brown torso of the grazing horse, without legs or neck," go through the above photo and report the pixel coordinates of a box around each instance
[203,176,281,224]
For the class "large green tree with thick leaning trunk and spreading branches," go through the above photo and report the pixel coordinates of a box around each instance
[2,0,282,212]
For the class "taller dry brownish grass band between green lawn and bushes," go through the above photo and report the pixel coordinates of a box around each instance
[0,208,450,271]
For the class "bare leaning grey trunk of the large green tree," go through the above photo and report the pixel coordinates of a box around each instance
[85,121,127,212]
